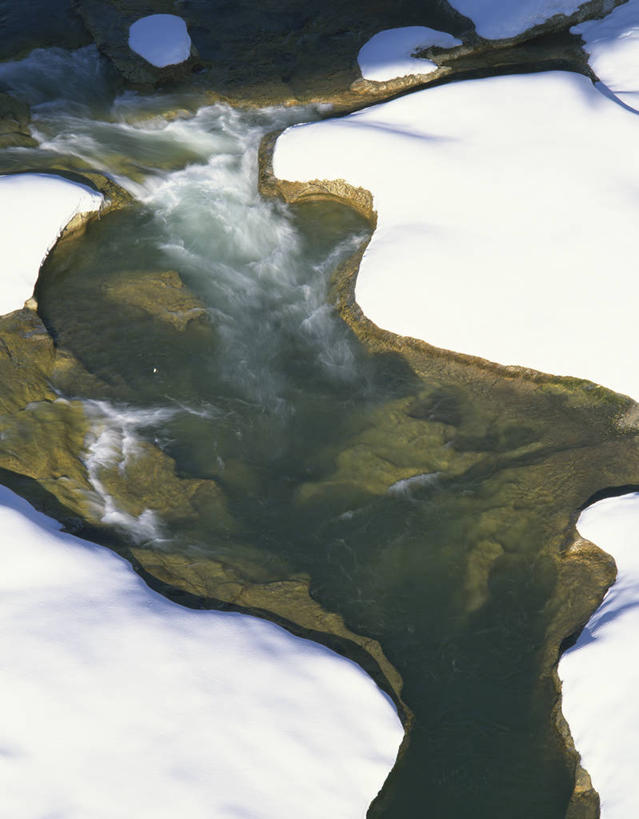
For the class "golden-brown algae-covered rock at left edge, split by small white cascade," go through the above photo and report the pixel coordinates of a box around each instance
[0,308,235,536]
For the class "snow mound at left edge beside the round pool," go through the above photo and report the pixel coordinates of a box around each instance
[0,173,103,314]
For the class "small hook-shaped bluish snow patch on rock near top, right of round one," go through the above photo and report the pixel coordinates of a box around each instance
[357,26,461,82]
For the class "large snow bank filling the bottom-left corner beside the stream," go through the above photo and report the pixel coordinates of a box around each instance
[0,488,402,819]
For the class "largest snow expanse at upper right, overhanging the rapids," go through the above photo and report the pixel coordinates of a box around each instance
[274,72,639,399]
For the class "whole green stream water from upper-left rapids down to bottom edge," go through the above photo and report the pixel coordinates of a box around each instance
[4,44,624,819]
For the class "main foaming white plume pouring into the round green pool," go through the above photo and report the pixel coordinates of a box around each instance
[144,124,364,406]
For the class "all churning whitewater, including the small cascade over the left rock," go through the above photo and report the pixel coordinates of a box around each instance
[0,46,365,542]
